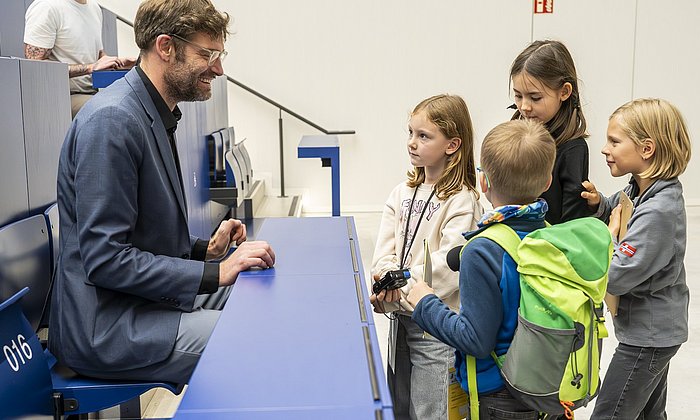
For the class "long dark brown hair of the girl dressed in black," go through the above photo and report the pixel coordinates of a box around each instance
[510,40,588,147]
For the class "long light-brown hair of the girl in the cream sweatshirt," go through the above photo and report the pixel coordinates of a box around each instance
[407,94,478,200]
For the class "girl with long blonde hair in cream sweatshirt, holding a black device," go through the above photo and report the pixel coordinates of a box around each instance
[370,95,483,420]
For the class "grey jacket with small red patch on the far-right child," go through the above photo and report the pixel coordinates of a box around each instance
[596,178,690,347]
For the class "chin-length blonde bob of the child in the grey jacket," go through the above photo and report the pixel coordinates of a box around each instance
[610,98,691,179]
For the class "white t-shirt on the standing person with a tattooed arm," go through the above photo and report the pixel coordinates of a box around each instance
[24,0,103,93]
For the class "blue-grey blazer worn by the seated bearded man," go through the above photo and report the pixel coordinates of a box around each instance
[49,69,204,371]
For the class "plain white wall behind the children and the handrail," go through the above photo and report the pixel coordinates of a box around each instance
[100,0,700,212]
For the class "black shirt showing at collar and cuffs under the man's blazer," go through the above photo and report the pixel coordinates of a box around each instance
[136,66,219,294]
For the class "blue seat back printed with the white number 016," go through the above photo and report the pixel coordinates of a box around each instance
[0,287,53,418]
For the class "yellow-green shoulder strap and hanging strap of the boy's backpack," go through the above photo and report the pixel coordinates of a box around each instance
[459,223,520,420]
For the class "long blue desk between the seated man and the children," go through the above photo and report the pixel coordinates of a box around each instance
[175,217,393,420]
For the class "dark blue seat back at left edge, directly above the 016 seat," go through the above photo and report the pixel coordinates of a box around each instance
[0,214,52,330]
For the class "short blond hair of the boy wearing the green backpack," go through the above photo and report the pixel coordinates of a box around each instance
[481,120,557,204]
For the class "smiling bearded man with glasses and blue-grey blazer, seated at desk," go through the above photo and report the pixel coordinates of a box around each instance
[49,0,275,383]
